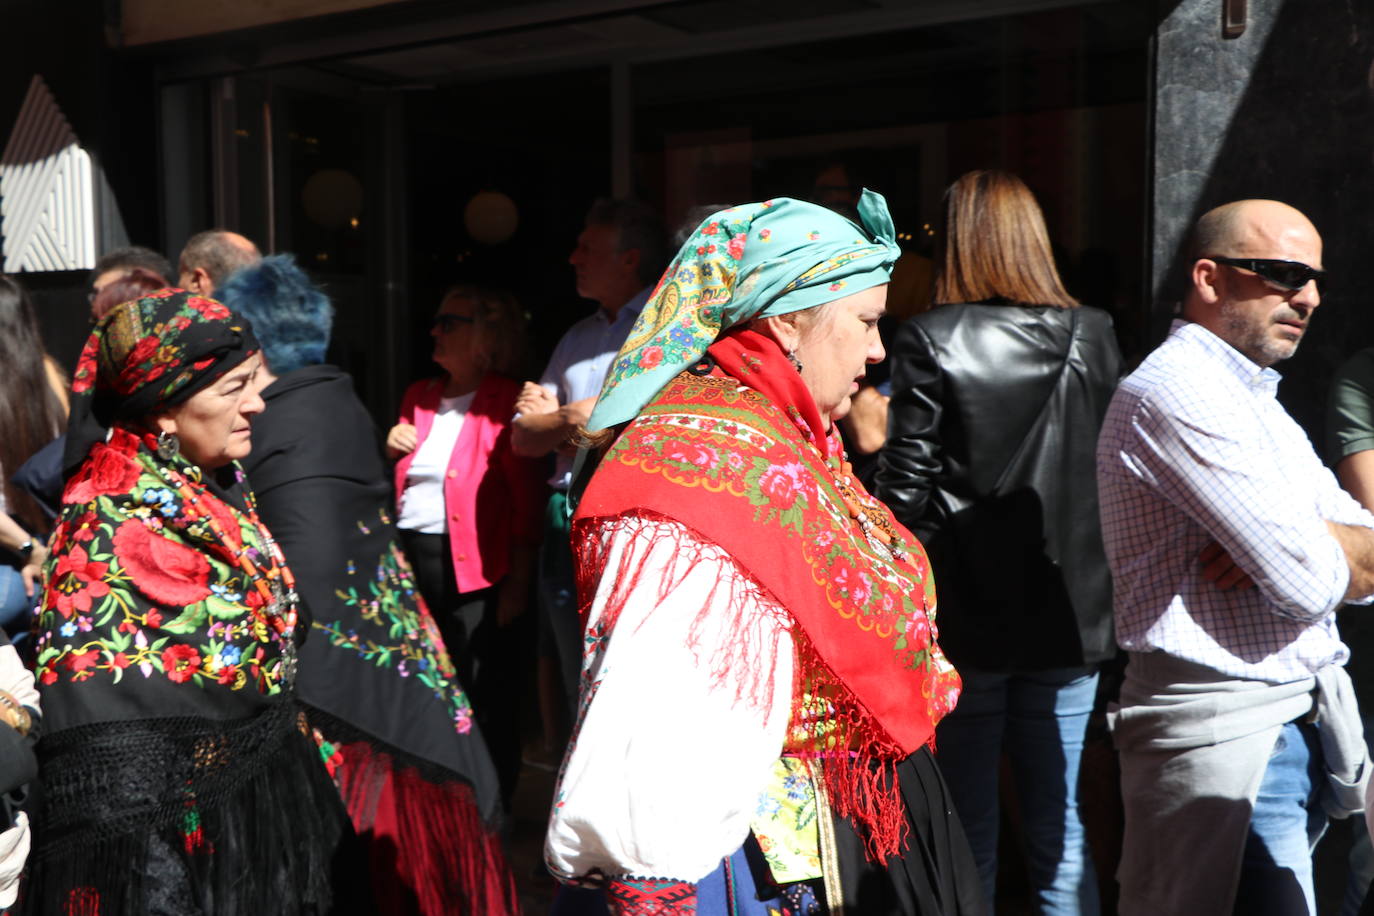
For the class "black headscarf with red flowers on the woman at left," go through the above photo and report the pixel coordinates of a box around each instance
[62,288,258,478]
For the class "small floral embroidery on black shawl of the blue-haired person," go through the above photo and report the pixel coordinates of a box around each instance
[312,521,473,735]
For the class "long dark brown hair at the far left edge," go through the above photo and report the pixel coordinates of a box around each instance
[0,273,67,531]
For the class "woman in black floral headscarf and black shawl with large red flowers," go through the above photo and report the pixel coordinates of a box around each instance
[25,290,365,916]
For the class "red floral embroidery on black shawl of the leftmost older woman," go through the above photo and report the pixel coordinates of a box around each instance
[36,428,294,695]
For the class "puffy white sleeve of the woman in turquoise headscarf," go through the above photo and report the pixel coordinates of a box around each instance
[544,519,793,882]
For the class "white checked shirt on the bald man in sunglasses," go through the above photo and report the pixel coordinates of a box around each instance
[1098,321,1374,684]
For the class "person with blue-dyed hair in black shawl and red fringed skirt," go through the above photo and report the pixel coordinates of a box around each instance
[220,254,517,916]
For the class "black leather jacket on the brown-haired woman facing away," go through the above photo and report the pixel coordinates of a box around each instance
[877,305,1121,672]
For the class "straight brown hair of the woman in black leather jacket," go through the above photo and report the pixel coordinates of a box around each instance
[934,169,1079,309]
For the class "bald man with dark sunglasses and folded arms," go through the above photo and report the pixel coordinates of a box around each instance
[1098,201,1374,916]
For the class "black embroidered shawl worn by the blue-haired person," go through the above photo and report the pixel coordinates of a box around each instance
[242,365,500,818]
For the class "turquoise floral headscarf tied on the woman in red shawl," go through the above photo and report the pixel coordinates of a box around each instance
[587,190,901,430]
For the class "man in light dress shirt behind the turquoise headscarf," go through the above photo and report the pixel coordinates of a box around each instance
[511,199,666,730]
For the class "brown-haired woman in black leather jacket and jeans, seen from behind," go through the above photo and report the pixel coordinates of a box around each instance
[877,170,1121,915]
